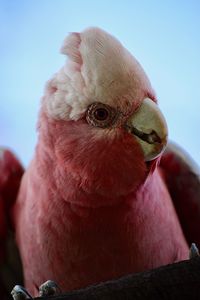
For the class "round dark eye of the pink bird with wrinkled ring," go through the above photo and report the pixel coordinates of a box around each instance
[86,102,117,128]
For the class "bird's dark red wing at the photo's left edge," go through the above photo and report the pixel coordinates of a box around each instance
[0,147,24,299]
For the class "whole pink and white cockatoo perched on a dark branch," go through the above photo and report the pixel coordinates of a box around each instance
[0,27,200,296]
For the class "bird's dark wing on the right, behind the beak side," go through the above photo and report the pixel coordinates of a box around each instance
[160,143,200,247]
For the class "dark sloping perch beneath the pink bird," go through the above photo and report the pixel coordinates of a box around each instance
[35,257,200,300]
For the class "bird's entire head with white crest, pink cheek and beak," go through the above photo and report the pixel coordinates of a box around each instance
[39,28,167,203]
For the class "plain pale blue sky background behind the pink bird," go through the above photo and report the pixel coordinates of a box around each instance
[0,0,200,166]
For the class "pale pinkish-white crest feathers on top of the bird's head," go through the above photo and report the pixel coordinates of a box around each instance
[43,28,153,120]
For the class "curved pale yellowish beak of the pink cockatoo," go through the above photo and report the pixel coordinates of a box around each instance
[125,98,168,161]
